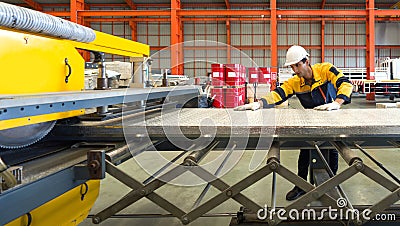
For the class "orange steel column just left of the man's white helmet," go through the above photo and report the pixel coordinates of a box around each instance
[270,0,278,90]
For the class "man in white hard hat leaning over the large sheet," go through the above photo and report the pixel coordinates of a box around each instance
[234,45,353,200]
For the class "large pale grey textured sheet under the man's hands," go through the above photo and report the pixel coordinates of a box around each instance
[125,109,400,138]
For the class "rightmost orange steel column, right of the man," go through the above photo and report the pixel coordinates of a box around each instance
[366,0,375,100]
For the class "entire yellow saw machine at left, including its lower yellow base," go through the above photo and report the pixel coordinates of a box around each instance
[0,2,150,225]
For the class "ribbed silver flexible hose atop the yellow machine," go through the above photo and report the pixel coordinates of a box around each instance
[0,2,96,42]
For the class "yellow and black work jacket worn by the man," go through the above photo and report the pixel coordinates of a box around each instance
[262,63,353,108]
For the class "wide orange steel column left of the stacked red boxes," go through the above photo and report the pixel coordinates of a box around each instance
[171,0,183,74]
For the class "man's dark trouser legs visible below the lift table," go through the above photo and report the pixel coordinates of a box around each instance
[297,149,339,183]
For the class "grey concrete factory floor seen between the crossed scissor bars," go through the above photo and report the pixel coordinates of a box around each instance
[79,96,400,226]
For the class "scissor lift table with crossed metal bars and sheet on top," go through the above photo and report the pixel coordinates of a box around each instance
[73,109,400,225]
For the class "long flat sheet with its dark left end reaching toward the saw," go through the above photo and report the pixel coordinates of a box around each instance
[53,108,400,142]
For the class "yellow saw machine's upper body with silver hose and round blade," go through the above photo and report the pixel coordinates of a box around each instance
[0,2,149,148]
